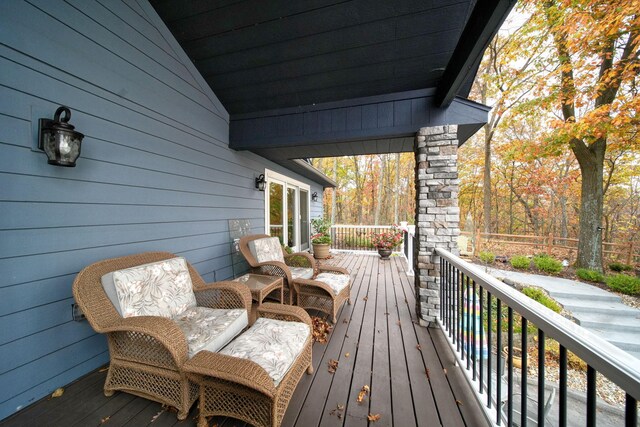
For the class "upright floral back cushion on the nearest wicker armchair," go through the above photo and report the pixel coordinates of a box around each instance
[113,258,196,318]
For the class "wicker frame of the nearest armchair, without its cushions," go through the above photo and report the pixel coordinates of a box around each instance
[73,252,251,420]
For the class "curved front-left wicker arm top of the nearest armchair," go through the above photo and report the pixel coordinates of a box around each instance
[102,316,189,367]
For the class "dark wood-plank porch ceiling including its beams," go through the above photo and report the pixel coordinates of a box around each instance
[150,0,516,181]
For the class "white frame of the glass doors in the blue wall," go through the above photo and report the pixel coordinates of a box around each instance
[264,169,311,251]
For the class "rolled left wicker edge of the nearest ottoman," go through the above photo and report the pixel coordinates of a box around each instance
[183,350,276,398]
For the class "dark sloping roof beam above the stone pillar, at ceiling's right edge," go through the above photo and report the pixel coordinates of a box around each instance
[434,0,516,107]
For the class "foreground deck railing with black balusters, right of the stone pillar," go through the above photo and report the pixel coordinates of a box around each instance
[436,249,640,426]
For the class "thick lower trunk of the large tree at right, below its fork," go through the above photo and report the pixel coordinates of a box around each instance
[571,139,607,272]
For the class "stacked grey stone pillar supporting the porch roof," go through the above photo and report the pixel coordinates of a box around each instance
[414,125,460,326]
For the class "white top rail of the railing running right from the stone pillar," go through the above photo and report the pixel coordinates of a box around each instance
[436,248,640,399]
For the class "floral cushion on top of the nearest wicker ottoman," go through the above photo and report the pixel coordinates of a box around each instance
[220,317,310,386]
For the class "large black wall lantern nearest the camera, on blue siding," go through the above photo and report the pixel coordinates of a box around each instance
[38,106,84,168]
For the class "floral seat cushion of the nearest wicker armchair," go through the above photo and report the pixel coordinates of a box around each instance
[172,307,249,358]
